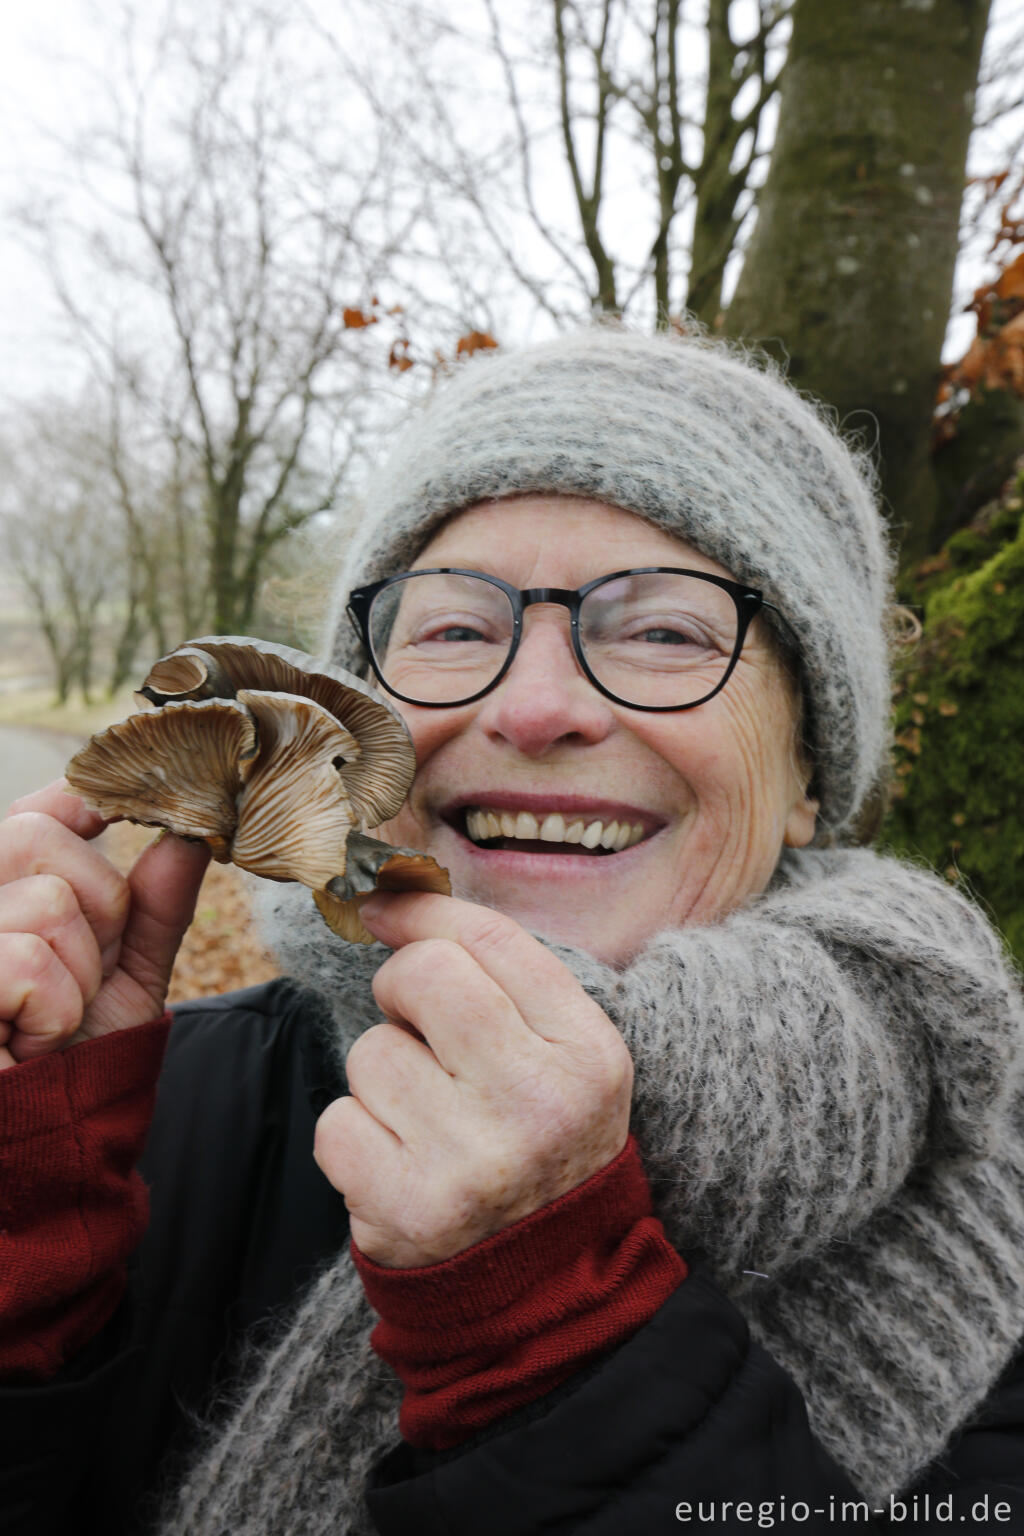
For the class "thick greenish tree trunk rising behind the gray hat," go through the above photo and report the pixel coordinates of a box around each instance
[726,0,989,561]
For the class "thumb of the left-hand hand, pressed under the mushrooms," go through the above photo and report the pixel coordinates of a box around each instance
[98,834,210,1011]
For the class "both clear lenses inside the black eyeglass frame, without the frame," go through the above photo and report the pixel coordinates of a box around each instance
[370,571,737,708]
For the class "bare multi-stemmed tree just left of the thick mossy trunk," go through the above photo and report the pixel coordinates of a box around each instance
[549,0,789,324]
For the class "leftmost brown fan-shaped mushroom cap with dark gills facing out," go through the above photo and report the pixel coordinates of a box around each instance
[66,699,256,863]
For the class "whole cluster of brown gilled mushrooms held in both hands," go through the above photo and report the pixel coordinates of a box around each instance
[66,634,451,943]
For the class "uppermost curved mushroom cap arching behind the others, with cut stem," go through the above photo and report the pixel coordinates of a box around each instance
[143,634,416,826]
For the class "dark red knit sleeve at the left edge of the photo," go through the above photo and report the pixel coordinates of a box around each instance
[0,1014,170,1382]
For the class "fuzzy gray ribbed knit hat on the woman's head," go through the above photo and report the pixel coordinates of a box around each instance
[329,326,890,840]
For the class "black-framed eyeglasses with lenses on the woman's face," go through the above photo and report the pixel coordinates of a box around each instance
[348,565,785,710]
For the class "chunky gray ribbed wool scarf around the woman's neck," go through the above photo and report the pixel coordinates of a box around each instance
[164,849,1024,1536]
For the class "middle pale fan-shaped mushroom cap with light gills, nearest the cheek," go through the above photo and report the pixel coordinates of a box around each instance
[232,688,359,886]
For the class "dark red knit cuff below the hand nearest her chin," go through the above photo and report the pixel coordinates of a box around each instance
[352,1137,686,1450]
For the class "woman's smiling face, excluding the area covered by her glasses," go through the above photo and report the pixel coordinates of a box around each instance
[373,496,817,965]
